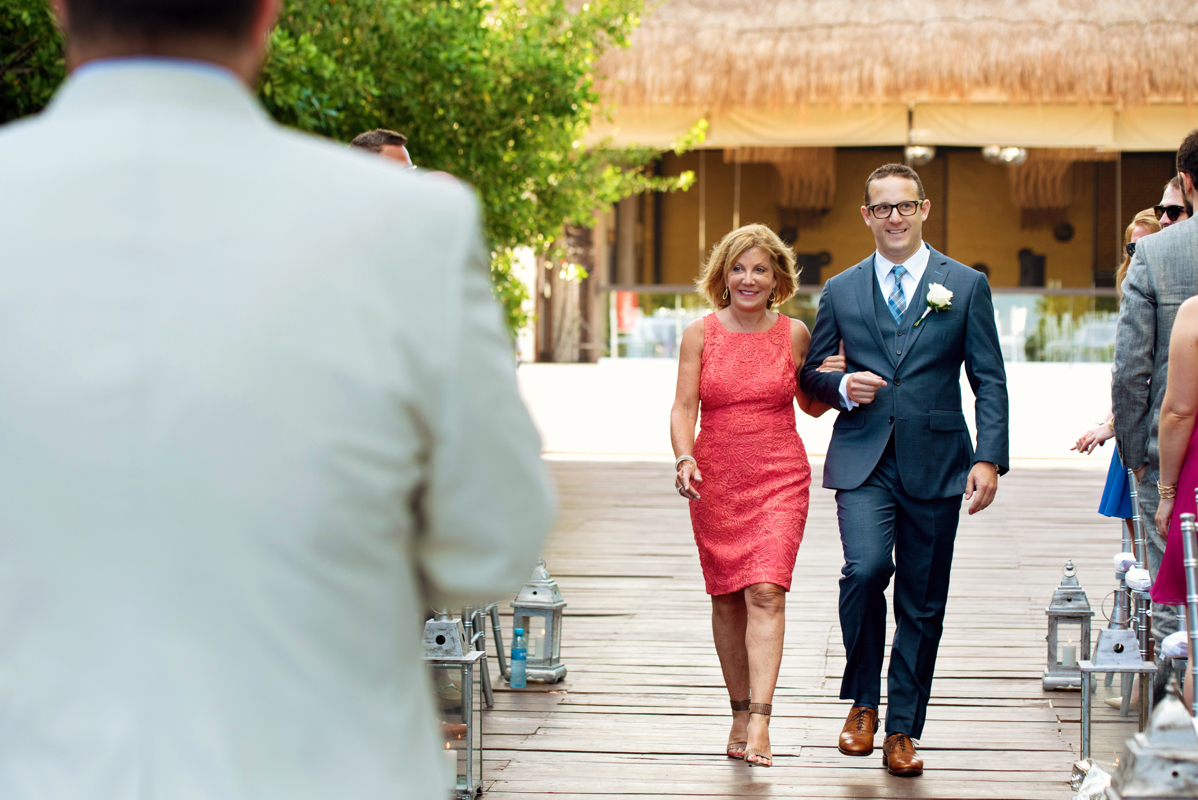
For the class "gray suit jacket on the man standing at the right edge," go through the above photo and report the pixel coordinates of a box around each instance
[1111,219,1198,472]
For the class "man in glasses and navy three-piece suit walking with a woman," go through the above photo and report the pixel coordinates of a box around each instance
[799,164,1008,775]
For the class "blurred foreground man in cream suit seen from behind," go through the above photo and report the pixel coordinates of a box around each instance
[0,0,551,800]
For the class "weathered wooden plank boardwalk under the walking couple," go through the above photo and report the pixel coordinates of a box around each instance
[484,462,1119,800]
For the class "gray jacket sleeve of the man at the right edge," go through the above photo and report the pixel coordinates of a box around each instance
[1111,250,1156,469]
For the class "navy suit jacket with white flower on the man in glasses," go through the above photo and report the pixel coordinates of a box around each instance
[799,248,1009,499]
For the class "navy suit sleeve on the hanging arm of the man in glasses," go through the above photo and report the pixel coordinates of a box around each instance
[964,275,1010,474]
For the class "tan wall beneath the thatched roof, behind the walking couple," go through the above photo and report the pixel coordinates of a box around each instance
[641,147,1172,287]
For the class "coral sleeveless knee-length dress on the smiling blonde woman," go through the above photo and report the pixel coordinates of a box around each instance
[690,314,811,594]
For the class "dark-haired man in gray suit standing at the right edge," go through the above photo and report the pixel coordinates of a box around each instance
[1111,129,1198,689]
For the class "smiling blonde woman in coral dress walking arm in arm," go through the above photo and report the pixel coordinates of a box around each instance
[670,225,843,766]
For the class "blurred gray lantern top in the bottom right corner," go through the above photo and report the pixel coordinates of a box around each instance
[1107,679,1198,800]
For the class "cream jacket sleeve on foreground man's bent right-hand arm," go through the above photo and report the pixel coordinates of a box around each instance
[417,194,553,607]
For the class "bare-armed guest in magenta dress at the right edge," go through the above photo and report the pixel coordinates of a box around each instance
[1152,297,1198,708]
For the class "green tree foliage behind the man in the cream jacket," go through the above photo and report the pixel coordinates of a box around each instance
[0,0,702,329]
